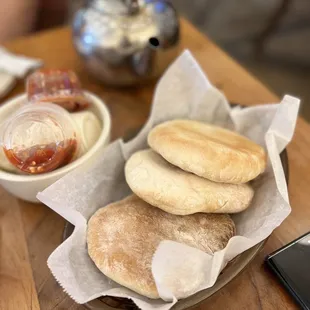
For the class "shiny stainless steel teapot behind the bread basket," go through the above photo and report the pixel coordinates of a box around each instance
[73,0,179,86]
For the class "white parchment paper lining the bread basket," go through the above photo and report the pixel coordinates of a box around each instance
[38,51,299,310]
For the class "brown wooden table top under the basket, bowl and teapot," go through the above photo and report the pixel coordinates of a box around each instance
[0,20,310,310]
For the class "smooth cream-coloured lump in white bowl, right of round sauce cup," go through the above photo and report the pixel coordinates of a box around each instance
[71,111,102,157]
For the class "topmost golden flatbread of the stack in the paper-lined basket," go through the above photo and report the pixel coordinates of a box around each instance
[148,120,266,184]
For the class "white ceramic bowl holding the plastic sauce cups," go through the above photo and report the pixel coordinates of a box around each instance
[0,92,111,202]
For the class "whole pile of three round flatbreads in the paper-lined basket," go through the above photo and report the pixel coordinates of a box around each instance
[87,120,266,299]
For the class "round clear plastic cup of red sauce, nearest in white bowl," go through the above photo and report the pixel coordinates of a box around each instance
[2,103,79,174]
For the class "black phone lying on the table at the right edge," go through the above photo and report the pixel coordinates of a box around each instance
[266,232,310,310]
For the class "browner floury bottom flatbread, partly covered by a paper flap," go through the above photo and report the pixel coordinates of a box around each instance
[87,195,235,299]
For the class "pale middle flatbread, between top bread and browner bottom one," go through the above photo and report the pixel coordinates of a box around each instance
[125,150,254,215]
